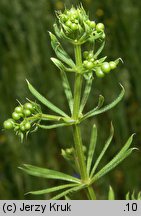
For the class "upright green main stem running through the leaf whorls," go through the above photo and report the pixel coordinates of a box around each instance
[73,45,96,200]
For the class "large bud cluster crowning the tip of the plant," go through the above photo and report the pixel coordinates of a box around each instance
[54,7,105,44]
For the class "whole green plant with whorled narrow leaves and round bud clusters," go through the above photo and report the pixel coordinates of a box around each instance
[4,6,138,200]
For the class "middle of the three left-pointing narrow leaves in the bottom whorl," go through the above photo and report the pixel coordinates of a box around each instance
[26,184,78,195]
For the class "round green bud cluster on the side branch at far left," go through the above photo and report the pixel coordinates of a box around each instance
[3,103,37,134]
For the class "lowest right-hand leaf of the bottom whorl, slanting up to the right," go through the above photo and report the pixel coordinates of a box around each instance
[91,148,134,183]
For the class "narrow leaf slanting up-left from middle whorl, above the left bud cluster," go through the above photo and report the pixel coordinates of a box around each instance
[26,80,68,117]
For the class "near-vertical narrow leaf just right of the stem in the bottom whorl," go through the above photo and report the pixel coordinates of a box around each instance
[87,124,97,175]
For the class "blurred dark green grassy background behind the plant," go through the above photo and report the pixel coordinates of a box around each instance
[0,0,141,199]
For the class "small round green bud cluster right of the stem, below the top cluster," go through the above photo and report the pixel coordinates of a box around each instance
[83,51,119,78]
